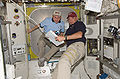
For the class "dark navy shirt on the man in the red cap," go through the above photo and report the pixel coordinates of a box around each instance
[65,21,86,46]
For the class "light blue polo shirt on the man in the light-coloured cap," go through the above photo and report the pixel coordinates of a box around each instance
[40,17,65,33]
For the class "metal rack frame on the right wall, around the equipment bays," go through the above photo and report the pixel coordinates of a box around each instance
[99,15,120,75]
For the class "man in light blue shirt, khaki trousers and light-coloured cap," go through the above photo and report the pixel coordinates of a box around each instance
[28,10,65,66]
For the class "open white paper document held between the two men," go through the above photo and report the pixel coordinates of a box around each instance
[45,30,64,46]
